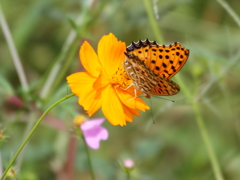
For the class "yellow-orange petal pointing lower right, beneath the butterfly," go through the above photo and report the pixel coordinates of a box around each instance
[116,88,150,112]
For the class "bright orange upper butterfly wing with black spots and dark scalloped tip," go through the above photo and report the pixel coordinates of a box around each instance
[127,39,189,79]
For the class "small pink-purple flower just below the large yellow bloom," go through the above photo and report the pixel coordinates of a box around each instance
[80,118,108,149]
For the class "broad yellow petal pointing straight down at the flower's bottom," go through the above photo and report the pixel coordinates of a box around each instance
[102,85,126,126]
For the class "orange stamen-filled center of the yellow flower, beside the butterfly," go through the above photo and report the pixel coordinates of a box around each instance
[110,67,132,88]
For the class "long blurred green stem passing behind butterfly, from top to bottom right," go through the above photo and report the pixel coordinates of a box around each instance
[143,0,226,180]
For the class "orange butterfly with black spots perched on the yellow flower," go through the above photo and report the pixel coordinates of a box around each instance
[123,39,189,98]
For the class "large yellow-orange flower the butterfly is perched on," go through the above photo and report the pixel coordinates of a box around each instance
[67,33,149,126]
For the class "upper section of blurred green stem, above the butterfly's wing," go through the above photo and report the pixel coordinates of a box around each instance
[143,0,164,43]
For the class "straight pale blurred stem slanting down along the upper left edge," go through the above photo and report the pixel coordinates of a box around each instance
[0,4,29,92]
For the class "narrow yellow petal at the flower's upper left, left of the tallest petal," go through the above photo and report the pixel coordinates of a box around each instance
[79,41,101,77]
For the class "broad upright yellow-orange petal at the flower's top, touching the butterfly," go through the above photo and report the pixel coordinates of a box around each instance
[98,33,126,78]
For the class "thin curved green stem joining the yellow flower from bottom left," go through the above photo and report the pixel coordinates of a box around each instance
[1,94,74,180]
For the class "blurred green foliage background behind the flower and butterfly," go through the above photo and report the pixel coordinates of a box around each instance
[0,0,240,180]
